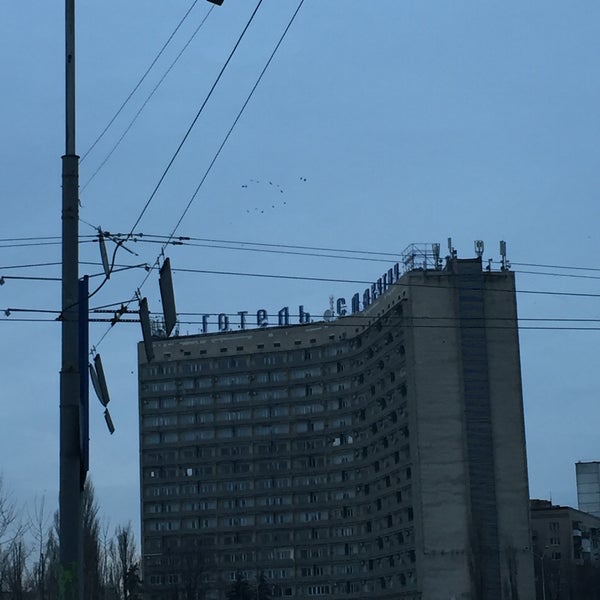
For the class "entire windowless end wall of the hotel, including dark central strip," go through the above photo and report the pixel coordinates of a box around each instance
[409,261,535,600]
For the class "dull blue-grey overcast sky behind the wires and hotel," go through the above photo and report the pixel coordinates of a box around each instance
[0,0,600,540]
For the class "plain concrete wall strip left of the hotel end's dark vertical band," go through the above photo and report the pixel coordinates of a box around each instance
[407,272,471,600]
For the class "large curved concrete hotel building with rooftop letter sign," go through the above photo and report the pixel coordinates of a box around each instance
[139,246,534,600]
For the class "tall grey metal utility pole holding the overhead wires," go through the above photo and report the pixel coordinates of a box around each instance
[59,0,83,600]
